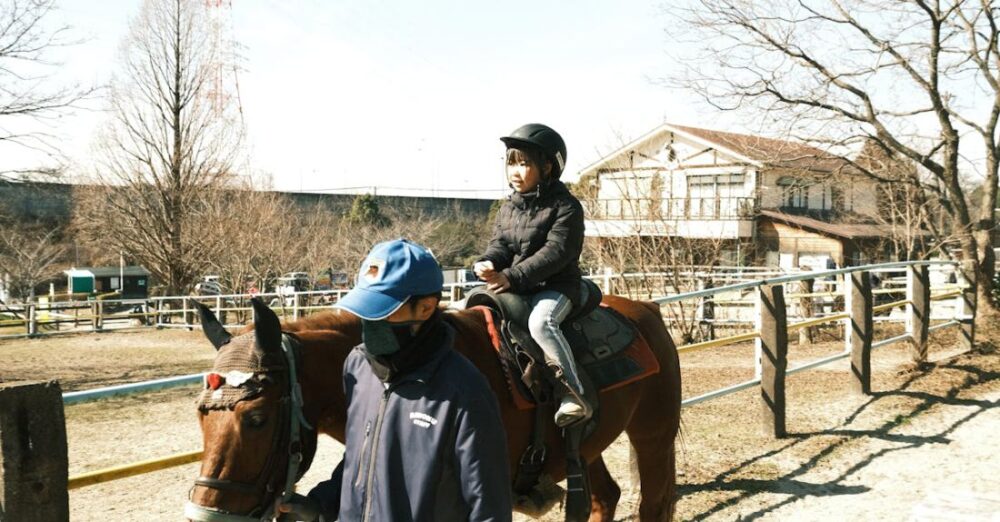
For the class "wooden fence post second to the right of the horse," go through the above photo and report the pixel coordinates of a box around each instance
[844,271,874,395]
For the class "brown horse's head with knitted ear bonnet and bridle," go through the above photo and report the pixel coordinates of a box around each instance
[184,298,315,522]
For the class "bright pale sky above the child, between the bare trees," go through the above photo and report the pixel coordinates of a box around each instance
[8,0,720,195]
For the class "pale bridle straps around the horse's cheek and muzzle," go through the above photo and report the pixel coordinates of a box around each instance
[184,333,314,522]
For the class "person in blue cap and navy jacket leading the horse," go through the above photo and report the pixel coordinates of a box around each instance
[279,239,512,521]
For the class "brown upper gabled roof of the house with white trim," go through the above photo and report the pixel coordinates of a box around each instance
[580,123,849,175]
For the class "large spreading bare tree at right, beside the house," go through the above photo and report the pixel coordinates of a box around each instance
[672,0,1000,310]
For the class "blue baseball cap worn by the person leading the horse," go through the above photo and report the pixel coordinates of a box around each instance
[334,238,444,321]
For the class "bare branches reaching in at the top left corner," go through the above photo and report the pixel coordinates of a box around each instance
[0,0,93,180]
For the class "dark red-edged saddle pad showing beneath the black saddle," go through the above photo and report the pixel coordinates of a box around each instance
[473,305,660,410]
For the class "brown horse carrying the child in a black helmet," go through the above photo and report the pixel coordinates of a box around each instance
[188,296,681,521]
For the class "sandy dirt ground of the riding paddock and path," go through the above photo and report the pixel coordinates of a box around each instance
[0,322,1000,521]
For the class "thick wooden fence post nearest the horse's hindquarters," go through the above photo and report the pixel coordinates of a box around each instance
[756,284,788,438]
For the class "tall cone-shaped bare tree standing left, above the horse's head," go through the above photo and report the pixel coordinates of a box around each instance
[77,0,242,293]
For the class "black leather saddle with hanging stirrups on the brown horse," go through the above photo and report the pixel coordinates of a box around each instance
[465,279,659,520]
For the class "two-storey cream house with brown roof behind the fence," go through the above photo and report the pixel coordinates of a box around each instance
[580,123,887,269]
